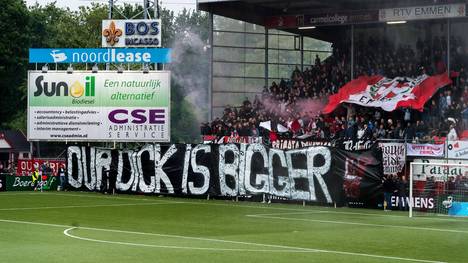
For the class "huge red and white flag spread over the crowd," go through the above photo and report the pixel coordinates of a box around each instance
[323,73,452,114]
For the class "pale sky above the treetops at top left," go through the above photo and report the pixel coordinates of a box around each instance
[26,0,196,13]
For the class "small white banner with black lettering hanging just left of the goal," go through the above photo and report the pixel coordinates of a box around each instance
[379,142,406,174]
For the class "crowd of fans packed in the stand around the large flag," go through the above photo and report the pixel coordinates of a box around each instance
[201,34,468,144]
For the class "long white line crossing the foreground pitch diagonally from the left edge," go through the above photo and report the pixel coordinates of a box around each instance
[0,219,447,263]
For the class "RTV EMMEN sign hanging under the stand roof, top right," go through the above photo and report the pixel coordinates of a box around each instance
[379,4,466,22]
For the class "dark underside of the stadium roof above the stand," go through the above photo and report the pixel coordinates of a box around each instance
[198,0,466,40]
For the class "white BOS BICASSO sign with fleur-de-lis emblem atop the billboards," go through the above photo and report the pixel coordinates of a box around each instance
[101,19,161,47]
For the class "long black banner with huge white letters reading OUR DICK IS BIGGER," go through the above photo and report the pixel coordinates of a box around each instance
[67,144,382,205]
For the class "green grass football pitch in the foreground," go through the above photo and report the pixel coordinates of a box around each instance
[0,192,468,263]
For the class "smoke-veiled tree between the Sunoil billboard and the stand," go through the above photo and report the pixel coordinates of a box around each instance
[165,9,210,142]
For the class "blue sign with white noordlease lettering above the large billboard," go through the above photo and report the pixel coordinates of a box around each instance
[29,48,171,63]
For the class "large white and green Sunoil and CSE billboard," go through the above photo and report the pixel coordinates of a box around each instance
[28,71,170,142]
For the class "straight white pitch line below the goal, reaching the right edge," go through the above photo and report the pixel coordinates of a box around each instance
[247,215,468,234]
